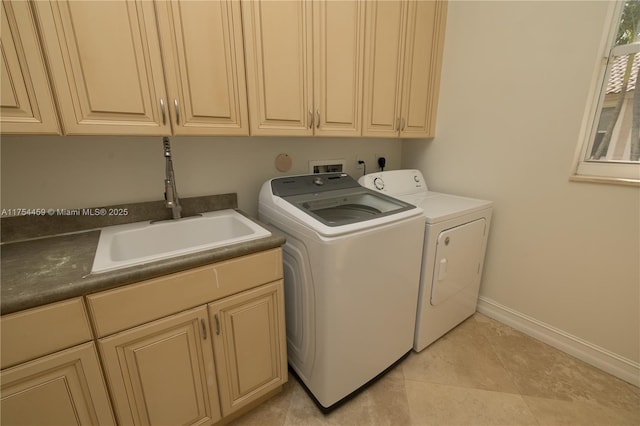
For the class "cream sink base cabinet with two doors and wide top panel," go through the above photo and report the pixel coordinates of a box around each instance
[87,248,287,425]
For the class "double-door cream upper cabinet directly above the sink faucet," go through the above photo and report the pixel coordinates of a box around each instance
[34,1,248,135]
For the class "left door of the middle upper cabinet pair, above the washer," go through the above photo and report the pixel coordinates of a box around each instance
[242,0,314,136]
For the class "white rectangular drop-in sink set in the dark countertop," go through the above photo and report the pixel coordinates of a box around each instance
[91,209,271,273]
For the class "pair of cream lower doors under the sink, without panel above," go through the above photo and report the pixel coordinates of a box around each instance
[98,280,287,425]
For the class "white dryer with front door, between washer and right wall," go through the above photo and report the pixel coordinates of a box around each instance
[358,170,493,352]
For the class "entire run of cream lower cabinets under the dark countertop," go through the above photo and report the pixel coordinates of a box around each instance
[0,248,287,426]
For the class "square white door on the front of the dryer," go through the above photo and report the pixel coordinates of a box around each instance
[431,218,486,306]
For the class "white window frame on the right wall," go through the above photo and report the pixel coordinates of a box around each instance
[570,0,640,186]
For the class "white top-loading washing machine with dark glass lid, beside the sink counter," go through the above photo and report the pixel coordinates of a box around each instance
[258,173,424,411]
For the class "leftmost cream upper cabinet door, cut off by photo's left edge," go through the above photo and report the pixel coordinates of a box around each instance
[0,0,60,134]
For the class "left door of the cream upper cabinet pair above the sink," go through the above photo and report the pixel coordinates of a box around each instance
[33,0,171,135]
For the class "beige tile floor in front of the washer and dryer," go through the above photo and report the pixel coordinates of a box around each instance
[232,314,640,426]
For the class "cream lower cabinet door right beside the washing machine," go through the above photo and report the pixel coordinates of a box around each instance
[209,280,287,416]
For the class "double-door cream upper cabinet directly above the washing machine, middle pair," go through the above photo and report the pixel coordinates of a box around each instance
[242,1,364,136]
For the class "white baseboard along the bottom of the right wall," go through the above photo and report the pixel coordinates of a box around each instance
[477,296,640,387]
